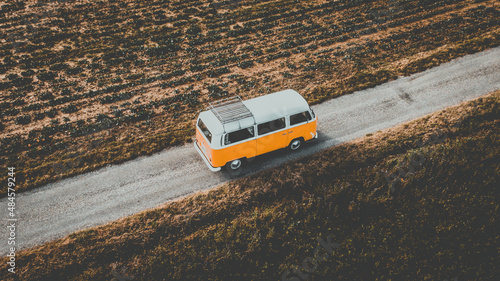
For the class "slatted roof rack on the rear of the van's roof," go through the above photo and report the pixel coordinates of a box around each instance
[207,96,255,130]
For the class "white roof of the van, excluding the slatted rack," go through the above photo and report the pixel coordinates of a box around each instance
[200,89,309,135]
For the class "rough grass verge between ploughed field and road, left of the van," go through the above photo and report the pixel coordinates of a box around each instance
[1,123,194,197]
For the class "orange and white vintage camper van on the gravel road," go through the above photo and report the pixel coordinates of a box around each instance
[194,90,318,172]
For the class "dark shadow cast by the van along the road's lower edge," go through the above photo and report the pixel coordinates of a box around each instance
[220,130,341,180]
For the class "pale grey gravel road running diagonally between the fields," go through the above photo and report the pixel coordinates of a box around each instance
[0,47,500,255]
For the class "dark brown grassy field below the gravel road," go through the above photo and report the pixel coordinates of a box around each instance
[0,91,500,280]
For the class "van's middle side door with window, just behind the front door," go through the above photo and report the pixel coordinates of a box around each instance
[257,117,288,155]
